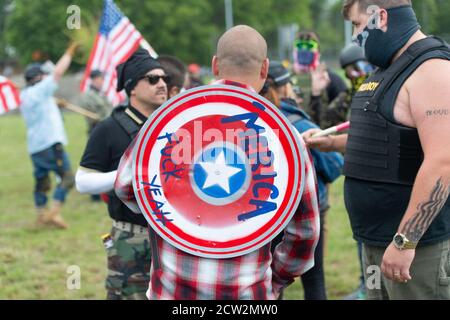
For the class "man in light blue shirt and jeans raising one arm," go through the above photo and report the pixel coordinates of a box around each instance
[20,43,78,229]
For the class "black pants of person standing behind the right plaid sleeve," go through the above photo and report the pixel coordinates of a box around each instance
[271,211,327,300]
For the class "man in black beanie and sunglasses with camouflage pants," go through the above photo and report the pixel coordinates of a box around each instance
[76,49,169,300]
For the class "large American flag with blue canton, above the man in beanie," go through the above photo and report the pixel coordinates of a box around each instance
[81,0,157,105]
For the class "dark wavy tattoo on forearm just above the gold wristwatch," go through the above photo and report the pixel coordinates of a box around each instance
[401,178,450,243]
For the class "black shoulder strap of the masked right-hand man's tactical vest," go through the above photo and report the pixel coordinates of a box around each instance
[367,36,450,111]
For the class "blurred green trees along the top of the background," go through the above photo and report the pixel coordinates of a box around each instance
[0,0,450,68]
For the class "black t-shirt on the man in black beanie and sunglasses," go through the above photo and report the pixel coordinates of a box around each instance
[80,107,147,227]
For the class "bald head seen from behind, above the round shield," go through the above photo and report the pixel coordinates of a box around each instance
[213,25,267,89]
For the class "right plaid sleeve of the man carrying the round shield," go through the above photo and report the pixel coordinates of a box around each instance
[272,139,320,294]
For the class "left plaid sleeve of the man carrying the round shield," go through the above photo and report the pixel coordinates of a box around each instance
[114,139,141,214]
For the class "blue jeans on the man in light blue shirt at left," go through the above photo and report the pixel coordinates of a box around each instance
[31,144,73,208]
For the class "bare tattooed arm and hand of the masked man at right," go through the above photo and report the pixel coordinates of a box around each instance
[381,60,450,282]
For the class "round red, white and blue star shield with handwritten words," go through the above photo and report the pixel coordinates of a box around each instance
[133,85,304,259]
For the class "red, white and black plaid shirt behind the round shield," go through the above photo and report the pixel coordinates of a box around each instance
[115,81,320,300]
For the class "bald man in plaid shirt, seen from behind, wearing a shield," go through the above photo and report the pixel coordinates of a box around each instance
[116,26,319,300]
